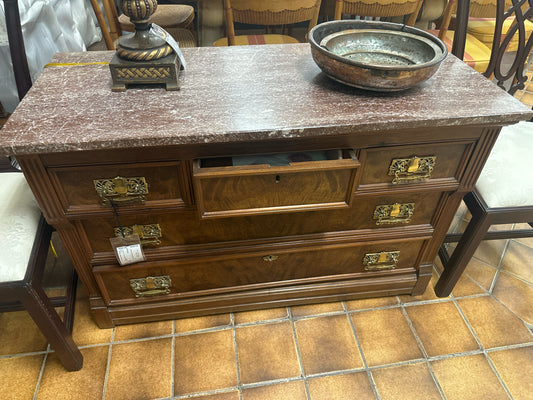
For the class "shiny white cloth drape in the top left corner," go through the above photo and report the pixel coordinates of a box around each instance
[0,0,102,112]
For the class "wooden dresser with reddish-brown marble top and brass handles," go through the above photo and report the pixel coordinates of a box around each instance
[0,44,530,327]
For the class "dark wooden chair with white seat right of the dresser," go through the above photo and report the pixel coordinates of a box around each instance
[435,0,533,297]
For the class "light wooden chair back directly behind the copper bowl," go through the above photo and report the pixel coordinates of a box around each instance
[335,0,423,26]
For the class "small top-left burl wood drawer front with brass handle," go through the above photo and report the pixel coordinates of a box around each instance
[50,162,187,212]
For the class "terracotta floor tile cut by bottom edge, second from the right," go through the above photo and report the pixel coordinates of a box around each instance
[431,354,509,400]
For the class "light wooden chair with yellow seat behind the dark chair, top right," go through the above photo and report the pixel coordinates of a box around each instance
[432,0,533,73]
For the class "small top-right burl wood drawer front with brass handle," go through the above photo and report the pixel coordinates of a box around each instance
[357,142,472,191]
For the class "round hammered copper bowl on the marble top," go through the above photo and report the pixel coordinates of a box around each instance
[309,20,448,92]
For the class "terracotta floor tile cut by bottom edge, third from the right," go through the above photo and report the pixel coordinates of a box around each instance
[372,363,441,400]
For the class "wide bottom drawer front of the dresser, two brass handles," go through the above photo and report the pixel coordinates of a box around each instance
[94,239,424,304]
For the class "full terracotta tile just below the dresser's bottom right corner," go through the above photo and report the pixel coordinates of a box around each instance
[405,301,479,357]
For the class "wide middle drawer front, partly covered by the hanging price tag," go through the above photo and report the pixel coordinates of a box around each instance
[79,192,443,253]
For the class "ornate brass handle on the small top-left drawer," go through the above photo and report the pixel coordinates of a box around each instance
[93,176,148,205]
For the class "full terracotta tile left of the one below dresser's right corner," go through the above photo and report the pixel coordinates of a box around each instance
[351,308,423,366]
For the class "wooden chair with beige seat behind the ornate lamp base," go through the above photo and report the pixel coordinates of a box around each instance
[91,0,196,50]
